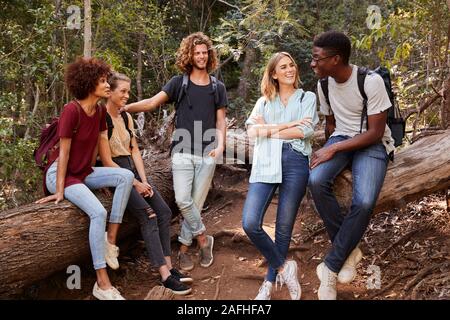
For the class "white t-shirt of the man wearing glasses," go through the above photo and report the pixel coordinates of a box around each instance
[317,65,395,154]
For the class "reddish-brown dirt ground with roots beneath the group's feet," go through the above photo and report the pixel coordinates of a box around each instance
[25,166,450,300]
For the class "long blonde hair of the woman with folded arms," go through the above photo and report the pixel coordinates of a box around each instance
[261,52,302,101]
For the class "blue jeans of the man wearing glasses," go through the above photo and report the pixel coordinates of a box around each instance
[309,136,388,272]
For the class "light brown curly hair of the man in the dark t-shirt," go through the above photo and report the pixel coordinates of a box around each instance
[176,32,217,74]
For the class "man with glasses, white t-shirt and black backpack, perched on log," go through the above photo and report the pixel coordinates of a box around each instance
[309,31,394,300]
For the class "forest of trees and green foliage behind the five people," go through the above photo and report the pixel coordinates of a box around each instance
[0,0,450,210]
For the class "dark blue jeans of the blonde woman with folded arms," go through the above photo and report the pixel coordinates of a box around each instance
[242,143,309,282]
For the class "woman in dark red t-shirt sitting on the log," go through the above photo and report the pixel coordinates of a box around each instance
[36,58,134,300]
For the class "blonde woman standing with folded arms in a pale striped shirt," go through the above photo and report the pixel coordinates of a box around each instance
[242,52,318,300]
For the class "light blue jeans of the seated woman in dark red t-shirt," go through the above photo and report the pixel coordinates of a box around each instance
[45,161,134,270]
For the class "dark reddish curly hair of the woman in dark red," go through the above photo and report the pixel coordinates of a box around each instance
[64,57,111,99]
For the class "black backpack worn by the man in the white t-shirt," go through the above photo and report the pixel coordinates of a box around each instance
[320,67,406,147]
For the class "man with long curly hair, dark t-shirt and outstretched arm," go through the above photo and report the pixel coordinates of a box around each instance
[123,32,228,271]
